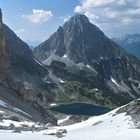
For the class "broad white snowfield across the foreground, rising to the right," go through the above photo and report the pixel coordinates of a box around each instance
[0,106,140,140]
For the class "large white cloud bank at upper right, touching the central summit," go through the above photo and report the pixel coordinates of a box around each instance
[74,0,140,28]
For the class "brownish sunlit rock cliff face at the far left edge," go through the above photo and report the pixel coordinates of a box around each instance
[0,9,10,84]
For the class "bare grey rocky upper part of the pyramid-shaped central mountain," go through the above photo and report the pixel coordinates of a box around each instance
[34,14,120,63]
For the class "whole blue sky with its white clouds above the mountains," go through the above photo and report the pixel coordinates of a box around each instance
[0,0,140,45]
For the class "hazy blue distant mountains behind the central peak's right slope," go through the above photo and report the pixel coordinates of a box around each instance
[112,34,140,59]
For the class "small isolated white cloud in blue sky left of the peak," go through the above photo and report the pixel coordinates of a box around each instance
[22,9,53,23]
